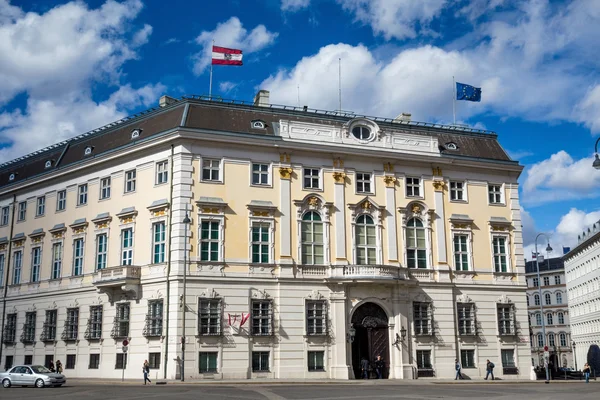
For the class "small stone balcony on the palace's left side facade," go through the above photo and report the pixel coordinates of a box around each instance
[93,265,142,303]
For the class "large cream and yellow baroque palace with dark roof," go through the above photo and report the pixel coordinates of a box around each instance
[0,91,531,379]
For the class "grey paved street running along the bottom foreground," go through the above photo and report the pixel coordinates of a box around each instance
[0,382,600,400]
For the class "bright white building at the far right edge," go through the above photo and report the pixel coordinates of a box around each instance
[563,221,600,369]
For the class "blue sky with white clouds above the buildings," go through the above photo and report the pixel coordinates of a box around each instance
[0,0,600,255]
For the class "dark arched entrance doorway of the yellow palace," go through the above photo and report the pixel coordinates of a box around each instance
[351,303,390,379]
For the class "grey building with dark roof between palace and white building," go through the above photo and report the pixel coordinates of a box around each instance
[525,258,575,370]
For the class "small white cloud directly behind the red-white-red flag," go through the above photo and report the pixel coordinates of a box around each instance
[192,17,278,75]
